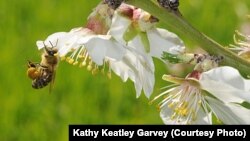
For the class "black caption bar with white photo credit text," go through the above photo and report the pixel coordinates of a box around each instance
[69,125,250,141]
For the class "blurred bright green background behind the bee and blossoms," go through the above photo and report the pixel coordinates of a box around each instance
[0,0,250,141]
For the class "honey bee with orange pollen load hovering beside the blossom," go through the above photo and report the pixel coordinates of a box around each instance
[27,42,59,91]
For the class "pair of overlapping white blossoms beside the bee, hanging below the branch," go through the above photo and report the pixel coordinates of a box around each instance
[37,3,184,97]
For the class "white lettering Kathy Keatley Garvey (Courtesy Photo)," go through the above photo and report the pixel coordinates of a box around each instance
[73,129,246,138]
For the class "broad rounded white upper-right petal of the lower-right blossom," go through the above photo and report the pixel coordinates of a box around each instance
[199,67,250,103]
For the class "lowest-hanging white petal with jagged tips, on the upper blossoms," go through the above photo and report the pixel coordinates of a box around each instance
[109,49,155,97]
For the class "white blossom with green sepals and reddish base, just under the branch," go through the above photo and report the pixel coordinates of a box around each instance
[109,4,184,59]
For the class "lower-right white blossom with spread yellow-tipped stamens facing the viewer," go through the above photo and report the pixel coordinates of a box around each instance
[154,67,250,124]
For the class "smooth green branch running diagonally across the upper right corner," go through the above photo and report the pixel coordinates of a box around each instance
[126,0,250,78]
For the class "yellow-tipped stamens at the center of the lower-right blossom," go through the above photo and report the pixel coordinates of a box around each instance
[165,82,202,124]
